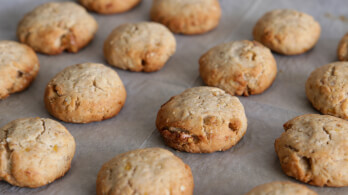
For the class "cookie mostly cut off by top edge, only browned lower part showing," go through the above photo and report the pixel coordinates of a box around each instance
[79,0,141,14]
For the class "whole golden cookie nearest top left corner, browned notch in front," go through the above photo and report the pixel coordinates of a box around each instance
[17,2,98,55]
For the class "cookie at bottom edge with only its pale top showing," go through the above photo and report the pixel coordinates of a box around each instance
[245,181,318,195]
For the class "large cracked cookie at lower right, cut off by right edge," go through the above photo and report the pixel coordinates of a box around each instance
[275,114,348,187]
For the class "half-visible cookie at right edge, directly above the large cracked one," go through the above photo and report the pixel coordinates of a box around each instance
[306,62,348,119]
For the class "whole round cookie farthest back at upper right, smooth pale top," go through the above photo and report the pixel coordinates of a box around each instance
[253,9,321,55]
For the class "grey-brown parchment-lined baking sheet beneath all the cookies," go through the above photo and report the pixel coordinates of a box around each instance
[0,0,348,195]
